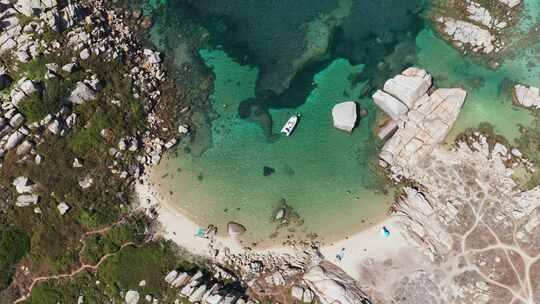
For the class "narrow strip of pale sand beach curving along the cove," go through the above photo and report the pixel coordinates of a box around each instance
[136,171,409,279]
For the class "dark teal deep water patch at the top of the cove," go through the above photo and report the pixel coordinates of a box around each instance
[138,0,427,144]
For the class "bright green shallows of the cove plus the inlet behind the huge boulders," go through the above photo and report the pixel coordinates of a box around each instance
[146,0,540,245]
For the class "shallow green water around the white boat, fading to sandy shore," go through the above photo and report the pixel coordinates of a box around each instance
[152,50,391,243]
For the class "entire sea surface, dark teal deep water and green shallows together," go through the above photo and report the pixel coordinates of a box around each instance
[144,0,540,244]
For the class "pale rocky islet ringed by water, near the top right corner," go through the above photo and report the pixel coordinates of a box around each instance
[435,0,521,54]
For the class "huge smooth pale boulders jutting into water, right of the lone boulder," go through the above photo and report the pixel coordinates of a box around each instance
[373,68,467,177]
